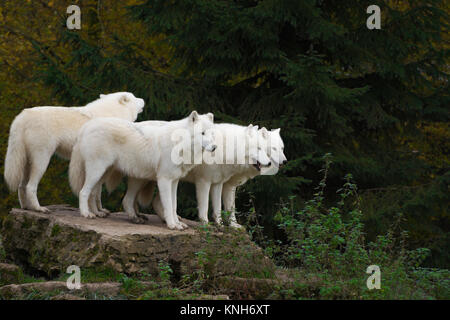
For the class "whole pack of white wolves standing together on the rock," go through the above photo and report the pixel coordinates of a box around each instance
[4,92,287,230]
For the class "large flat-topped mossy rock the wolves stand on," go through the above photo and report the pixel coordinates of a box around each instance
[1,205,274,278]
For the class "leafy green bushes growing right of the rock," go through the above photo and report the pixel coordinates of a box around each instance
[248,154,450,299]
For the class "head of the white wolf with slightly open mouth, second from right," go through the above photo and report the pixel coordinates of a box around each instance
[245,124,271,171]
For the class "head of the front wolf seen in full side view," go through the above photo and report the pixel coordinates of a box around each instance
[188,111,217,152]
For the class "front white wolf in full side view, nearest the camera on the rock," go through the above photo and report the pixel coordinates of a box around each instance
[69,111,216,230]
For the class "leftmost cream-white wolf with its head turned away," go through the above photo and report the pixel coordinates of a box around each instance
[4,92,144,212]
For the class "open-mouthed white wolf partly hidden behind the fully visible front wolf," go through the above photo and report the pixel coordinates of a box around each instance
[112,121,271,224]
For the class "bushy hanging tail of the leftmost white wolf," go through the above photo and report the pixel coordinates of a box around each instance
[4,112,28,192]
